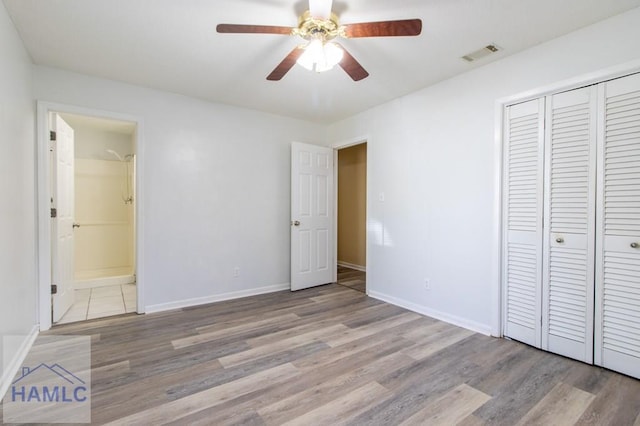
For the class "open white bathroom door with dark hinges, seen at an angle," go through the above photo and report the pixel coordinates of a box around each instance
[51,114,75,322]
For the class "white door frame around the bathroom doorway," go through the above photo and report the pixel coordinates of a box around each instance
[36,101,145,331]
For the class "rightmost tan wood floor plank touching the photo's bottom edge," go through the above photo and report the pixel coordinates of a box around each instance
[517,383,595,426]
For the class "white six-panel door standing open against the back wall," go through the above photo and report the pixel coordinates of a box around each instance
[291,142,336,290]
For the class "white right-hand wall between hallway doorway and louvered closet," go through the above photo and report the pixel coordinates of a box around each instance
[329,5,640,332]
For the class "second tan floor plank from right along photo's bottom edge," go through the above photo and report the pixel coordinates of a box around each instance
[401,384,491,426]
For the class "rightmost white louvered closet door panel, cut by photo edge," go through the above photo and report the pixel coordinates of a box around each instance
[595,74,640,378]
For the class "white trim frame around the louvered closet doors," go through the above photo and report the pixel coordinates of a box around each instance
[498,60,640,337]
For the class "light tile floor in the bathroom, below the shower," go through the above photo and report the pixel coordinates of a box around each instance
[56,284,136,324]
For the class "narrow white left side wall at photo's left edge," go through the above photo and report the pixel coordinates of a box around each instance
[0,2,37,386]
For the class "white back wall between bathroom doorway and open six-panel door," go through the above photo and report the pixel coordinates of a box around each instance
[34,67,326,310]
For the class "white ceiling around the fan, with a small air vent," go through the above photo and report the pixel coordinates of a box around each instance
[3,0,640,123]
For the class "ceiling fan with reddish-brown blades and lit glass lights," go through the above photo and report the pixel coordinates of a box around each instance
[216,0,422,81]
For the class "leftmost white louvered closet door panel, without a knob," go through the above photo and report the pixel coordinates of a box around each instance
[502,99,544,347]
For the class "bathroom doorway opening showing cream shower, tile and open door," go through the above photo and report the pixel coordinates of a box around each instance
[48,112,137,324]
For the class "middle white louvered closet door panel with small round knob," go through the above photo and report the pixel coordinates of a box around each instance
[542,86,597,363]
